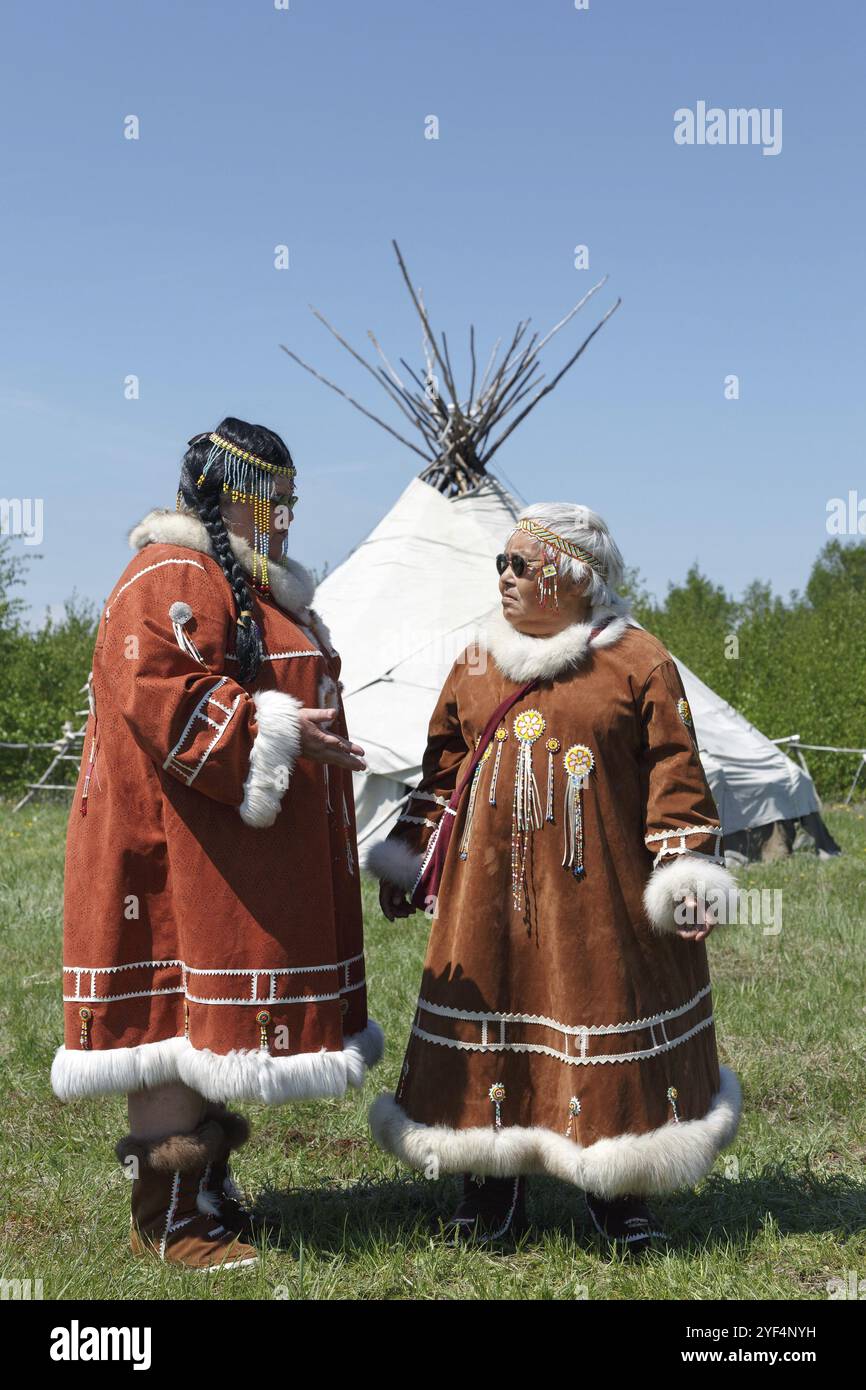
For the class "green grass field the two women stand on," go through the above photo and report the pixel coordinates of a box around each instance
[0,805,866,1300]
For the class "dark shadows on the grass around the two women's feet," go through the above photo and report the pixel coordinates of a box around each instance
[246,1166,866,1255]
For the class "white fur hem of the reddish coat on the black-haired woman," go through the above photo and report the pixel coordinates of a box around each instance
[51,1019,385,1105]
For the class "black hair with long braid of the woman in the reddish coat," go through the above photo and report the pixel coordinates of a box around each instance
[178,416,292,685]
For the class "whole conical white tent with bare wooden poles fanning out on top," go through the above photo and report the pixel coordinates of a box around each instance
[284,250,831,845]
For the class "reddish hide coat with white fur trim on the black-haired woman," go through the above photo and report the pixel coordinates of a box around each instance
[51,512,382,1104]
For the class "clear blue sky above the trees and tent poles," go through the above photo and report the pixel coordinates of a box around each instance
[0,0,866,616]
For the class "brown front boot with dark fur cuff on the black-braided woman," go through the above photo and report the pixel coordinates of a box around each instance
[115,1116,259,1270]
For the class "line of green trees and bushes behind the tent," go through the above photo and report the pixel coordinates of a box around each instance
[0,539,866,799]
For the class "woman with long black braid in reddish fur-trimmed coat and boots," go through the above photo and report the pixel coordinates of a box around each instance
[51,417,382,1269]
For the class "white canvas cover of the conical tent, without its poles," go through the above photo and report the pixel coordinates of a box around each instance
[316,475,819,845]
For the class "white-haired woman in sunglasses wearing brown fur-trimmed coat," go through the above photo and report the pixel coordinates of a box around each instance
[367,503,741,1251]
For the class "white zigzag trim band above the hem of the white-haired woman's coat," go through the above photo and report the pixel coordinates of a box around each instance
[411,984,713,1066]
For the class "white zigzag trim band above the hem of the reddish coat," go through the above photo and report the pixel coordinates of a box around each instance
[63,954,366,1005]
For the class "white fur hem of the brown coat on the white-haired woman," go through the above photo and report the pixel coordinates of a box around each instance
[370,1066,742,1200]
